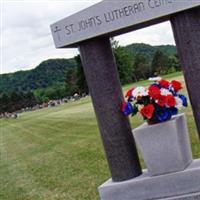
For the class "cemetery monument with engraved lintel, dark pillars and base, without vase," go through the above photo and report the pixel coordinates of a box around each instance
[51,0,200,200]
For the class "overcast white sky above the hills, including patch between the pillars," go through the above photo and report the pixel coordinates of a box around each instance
[0,0,175,74]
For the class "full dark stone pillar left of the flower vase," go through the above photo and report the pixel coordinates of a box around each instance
[79,38,141,181]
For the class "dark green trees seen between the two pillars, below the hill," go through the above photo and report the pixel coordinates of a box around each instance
[113,42,181,85]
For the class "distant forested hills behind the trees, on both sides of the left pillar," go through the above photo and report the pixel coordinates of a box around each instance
[0,43,176,93]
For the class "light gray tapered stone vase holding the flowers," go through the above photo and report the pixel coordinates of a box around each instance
[133,114,192,176]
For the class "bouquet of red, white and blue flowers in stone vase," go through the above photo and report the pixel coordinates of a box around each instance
[122,79,188,124]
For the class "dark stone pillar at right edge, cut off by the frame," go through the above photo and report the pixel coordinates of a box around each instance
[171,7,200,137]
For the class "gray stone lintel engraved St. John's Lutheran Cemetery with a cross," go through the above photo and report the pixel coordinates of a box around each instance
[51,0,200,48]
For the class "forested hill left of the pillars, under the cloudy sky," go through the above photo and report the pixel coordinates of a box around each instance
[0,59,76,93]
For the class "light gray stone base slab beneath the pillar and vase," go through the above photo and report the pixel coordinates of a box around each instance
[99,159,200,200]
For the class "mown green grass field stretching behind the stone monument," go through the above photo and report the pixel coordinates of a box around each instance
[0,73,200,200]
